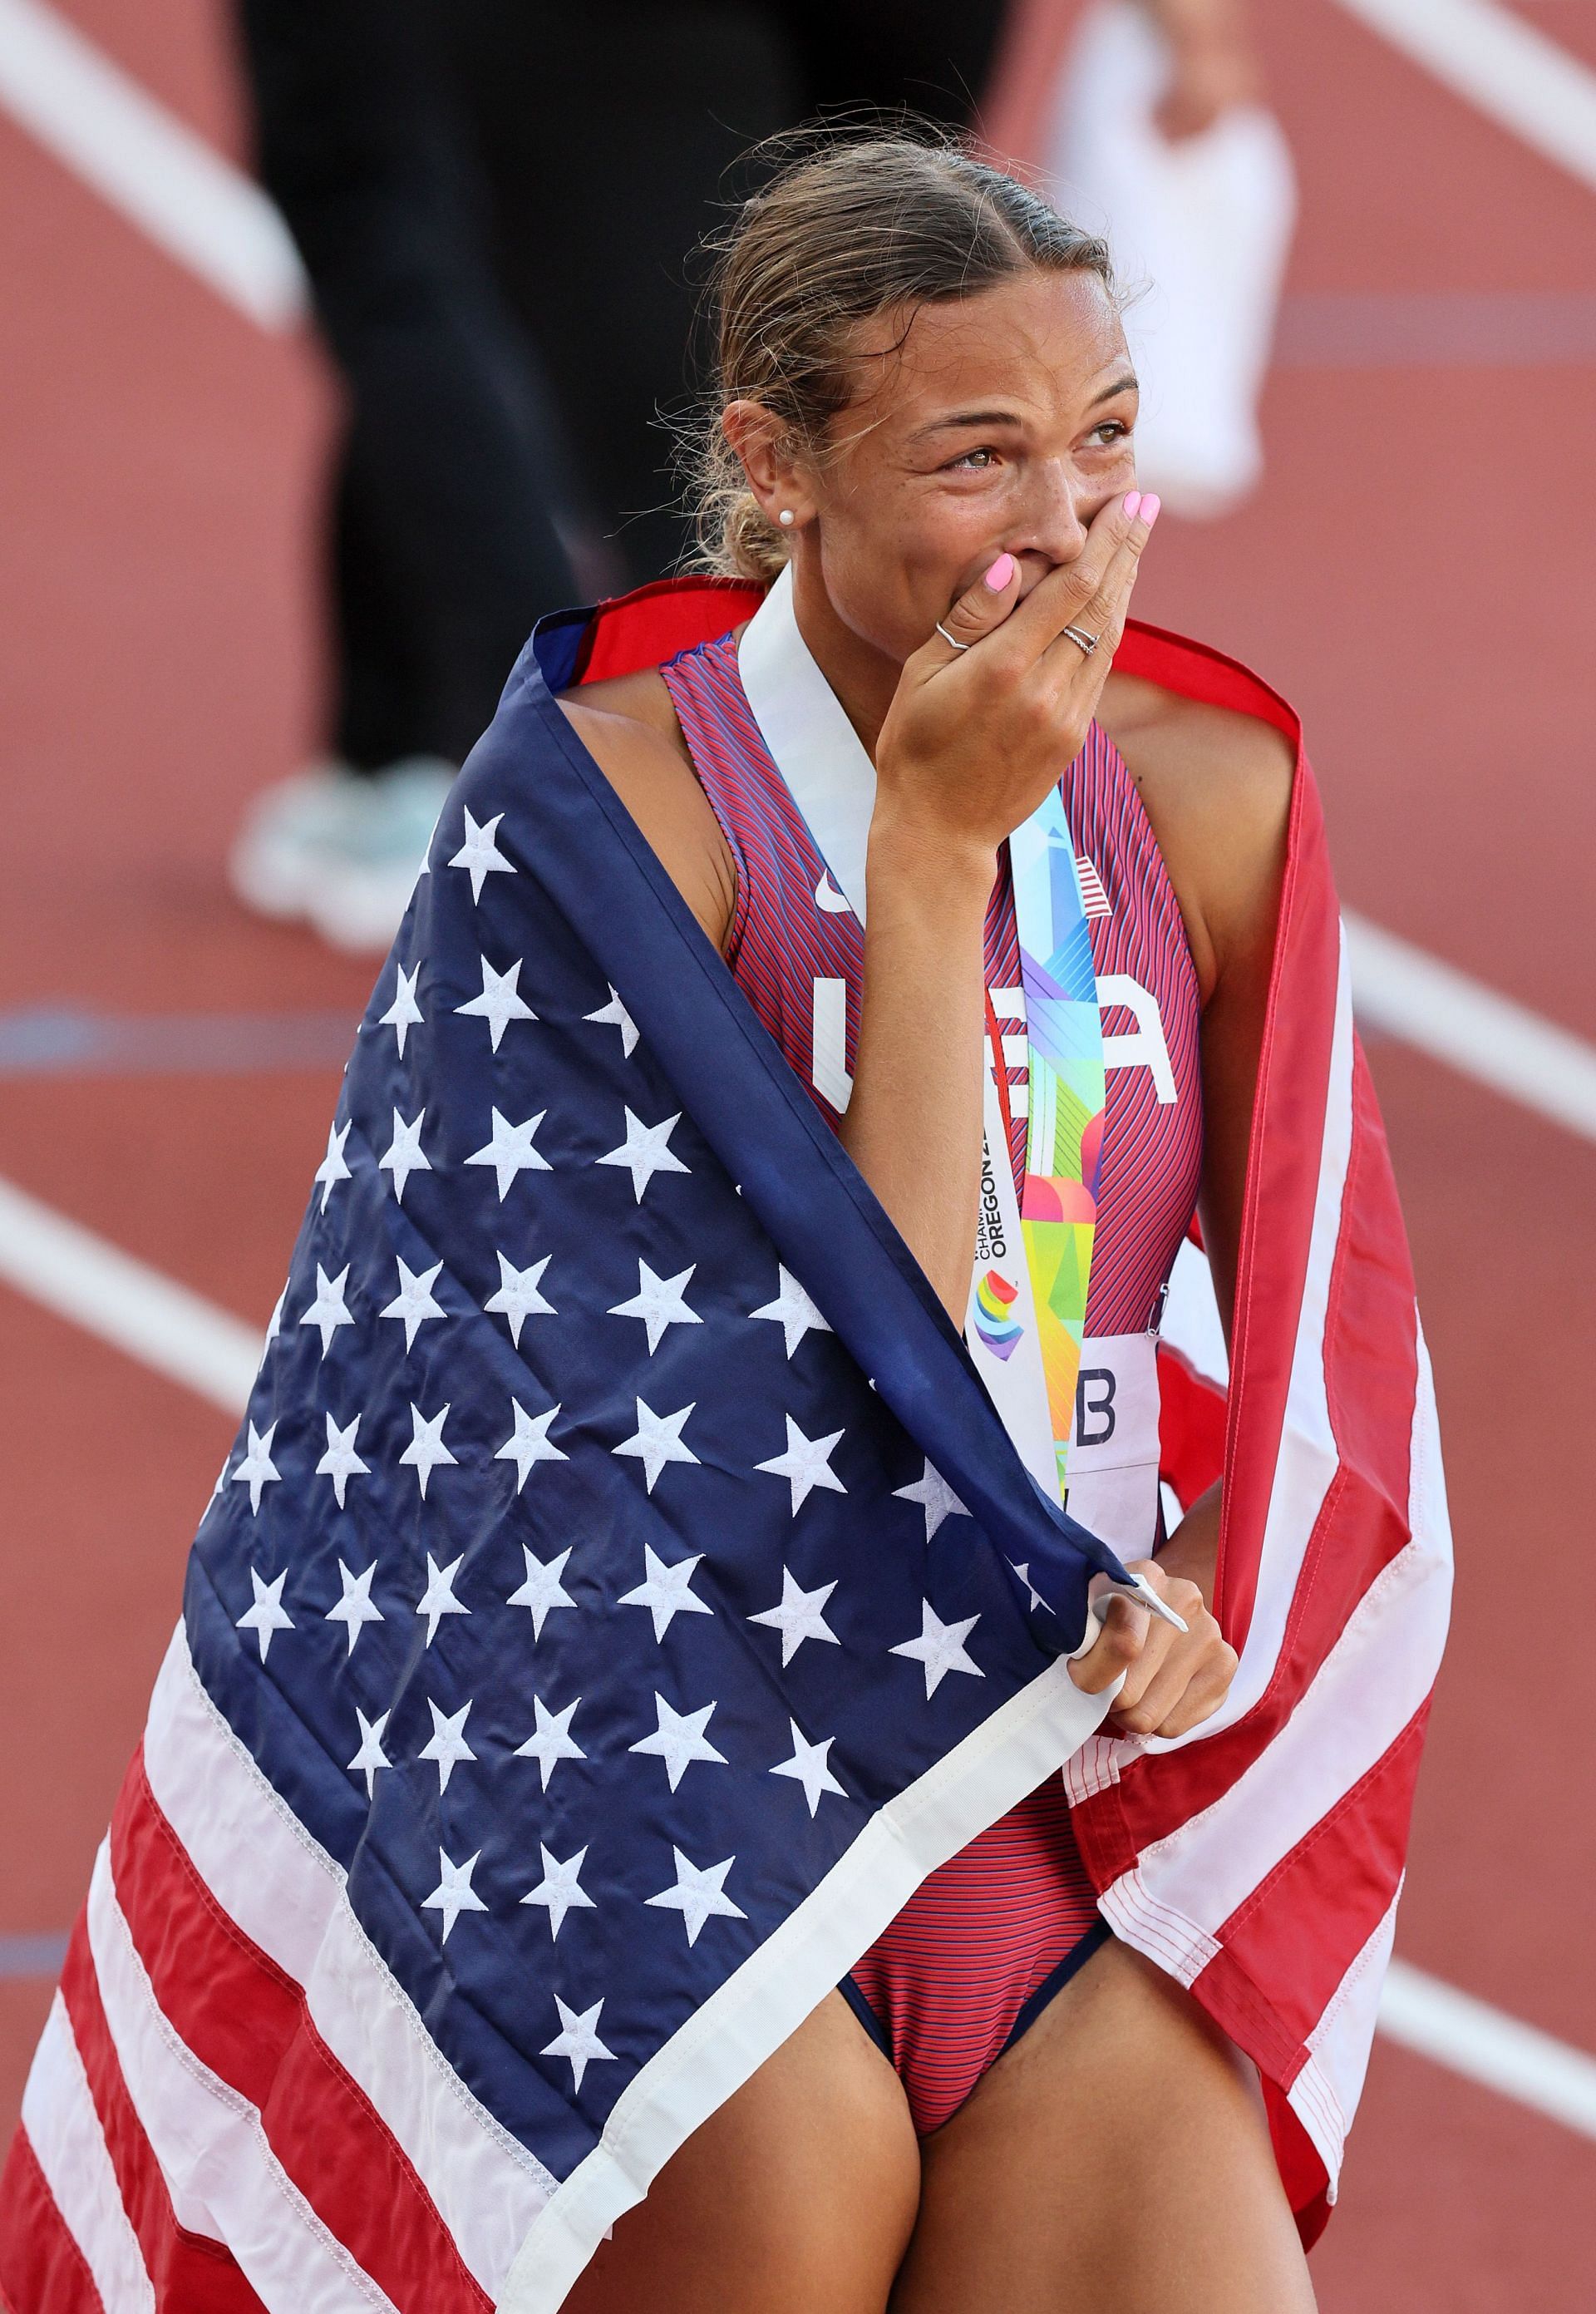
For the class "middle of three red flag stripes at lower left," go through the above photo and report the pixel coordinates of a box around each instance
[60,1916,266,2314]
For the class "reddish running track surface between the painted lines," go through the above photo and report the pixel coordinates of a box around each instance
[0,0,1596,2314]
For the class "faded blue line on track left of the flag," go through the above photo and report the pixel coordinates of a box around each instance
[0,1004,354,1078]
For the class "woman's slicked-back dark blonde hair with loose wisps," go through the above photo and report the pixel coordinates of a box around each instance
[687,125,1112,581]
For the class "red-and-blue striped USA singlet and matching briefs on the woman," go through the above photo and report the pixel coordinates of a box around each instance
[662,636,1203,2136]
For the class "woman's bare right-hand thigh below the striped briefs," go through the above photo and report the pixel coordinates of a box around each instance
[893,1944,1314,2314]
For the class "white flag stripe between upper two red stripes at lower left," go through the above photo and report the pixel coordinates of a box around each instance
[88,1842,398,2314]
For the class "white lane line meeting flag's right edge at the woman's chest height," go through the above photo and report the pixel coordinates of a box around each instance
[1346,914,1596,1141]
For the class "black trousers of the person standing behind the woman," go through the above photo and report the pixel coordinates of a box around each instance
[239,0,1002,768]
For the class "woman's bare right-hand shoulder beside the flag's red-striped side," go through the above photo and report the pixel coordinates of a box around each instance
[1099,671,1295,997]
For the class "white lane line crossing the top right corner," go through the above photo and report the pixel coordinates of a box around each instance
[1342,0,1596,192]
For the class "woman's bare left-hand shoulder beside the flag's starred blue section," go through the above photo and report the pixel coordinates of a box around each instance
[559,667,738,951]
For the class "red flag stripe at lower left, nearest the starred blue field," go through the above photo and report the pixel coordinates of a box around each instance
[111,1752,490,2314]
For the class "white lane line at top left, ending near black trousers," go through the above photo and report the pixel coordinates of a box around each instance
[0,0,305,331]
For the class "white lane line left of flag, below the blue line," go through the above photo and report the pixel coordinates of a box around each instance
[0,1180,261,1418]
